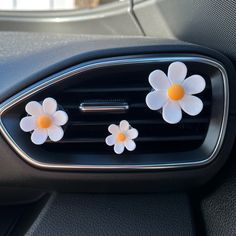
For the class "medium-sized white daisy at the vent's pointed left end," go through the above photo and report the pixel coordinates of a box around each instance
[20,98,68,145]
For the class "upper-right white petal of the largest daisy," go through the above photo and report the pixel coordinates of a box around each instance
[183,75,206,94]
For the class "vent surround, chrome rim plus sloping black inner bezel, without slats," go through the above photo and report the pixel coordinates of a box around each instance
[0,54,229,171]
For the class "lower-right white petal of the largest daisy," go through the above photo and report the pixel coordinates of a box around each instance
[179,95,203,116]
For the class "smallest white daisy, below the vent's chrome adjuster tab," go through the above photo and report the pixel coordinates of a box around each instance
[106,120,138,154]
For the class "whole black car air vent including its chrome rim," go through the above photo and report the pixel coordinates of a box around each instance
[1,56,227,169]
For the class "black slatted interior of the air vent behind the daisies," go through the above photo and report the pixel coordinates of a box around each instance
[44,65,211,155]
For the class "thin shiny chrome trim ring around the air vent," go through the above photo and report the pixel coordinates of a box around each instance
[0,56,229,171]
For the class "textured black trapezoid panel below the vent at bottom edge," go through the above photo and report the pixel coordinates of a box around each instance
[26,194,195,236]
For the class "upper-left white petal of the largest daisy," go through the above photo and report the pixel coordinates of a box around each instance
[148,70,170,90]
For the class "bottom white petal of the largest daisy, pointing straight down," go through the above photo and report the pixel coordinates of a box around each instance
[162,101,182,124]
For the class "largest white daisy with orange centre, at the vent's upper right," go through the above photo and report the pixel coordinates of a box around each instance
[146,62,206,124]
